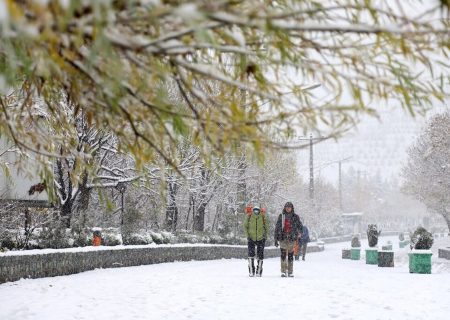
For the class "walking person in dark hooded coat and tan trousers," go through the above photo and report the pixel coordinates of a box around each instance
[275,202,302,277]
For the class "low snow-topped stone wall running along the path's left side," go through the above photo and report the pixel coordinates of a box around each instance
[0,245,323,283]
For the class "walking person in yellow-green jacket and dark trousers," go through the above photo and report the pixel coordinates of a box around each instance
[244,207,269,277]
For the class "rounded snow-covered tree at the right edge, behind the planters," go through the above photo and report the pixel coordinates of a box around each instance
[403,111,450,231]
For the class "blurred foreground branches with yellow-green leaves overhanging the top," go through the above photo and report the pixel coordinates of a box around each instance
[0,0,450,170]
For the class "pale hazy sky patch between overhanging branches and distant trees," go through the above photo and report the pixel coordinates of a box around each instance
[297,108,438,183]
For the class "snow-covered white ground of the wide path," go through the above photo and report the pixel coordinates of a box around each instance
[0,237,450,320]
